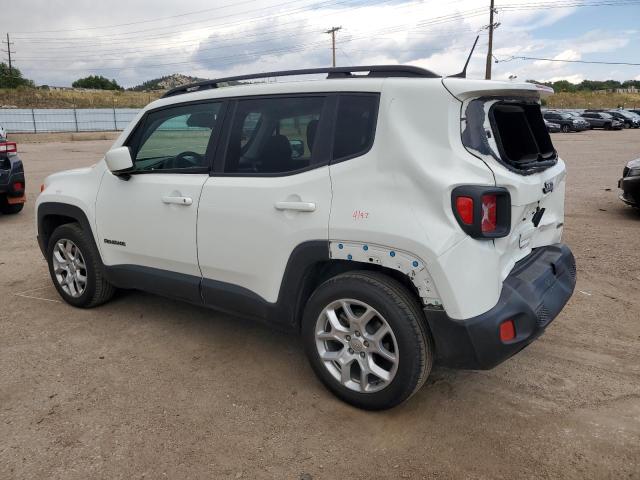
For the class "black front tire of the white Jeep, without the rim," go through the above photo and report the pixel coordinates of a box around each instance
[47,223,115,308]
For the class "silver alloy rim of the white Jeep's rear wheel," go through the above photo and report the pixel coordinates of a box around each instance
[315,299,399,393]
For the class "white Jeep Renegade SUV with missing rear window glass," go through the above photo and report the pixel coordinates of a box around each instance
[36,66,576,409]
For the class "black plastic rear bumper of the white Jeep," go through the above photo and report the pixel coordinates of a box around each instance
[426,244,576,369]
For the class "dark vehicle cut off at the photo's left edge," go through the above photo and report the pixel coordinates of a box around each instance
[0,140,26,214]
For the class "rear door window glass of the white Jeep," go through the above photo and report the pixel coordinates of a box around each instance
[224,96,325,174]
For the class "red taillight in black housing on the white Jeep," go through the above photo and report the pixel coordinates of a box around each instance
[451,185,511,238]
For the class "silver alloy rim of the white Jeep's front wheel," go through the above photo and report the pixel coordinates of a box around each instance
[53,238,87,298]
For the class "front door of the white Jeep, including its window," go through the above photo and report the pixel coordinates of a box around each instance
[96,102,221,299]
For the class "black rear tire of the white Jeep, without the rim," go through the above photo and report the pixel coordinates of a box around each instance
[302,271,434,410]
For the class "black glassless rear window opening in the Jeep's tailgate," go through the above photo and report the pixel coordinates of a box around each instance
[489,103,557,173]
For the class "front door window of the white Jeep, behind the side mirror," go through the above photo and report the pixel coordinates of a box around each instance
[132,102,221,172]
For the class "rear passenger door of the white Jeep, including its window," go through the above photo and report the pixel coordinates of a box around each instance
[198,95,332,305]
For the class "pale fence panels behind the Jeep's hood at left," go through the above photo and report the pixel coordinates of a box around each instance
[0,108,140,133]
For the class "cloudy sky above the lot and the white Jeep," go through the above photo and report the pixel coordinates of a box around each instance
[0,0,640,87]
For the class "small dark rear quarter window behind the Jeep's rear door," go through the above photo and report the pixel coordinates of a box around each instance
[333,94,379,161]
